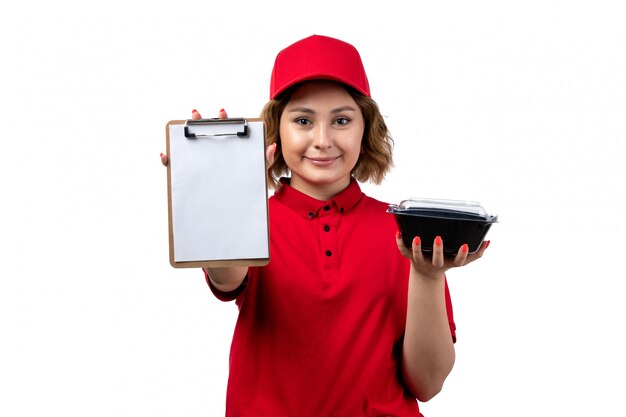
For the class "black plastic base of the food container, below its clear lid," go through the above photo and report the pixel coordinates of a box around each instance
[387,205,497,255]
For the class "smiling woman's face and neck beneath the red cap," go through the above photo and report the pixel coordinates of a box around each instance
[280,81,365,200]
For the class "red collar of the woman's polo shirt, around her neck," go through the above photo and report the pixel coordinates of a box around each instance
[274,178,363,219]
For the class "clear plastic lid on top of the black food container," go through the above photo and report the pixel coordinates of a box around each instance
[387,198,498,223]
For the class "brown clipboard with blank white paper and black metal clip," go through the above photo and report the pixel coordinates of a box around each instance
[166,118,269,268]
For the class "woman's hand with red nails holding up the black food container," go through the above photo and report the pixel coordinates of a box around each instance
[396,232,490,278]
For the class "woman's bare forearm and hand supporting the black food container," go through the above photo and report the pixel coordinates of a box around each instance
[396,233,488,402]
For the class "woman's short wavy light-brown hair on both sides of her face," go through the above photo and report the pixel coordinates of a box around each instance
[260,84,393,189]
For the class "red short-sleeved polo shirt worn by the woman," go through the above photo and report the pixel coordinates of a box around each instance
[205,180,455,417]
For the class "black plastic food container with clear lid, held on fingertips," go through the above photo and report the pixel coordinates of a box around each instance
[387,198,498,255]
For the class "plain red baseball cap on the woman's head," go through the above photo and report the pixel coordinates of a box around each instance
[270,35,370,99]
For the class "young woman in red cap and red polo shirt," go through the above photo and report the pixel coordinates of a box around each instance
[163,35,488,417]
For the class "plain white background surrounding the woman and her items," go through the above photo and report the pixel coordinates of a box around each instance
[0,0,626,417]
